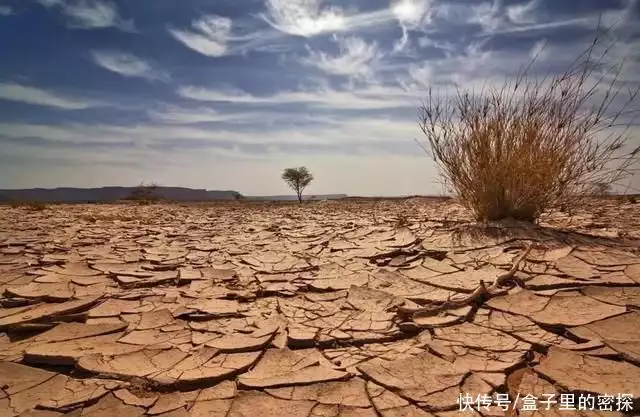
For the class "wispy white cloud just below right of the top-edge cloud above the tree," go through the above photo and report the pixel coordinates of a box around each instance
[303,36,383,79]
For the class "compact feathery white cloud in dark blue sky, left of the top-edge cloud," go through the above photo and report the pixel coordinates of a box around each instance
[169,15,232,57]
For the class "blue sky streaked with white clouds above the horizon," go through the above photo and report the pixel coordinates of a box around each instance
[0,0,640,195]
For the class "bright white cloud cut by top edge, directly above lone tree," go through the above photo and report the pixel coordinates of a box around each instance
[263,0,348,37]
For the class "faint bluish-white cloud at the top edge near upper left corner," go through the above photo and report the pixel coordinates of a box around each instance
[38,0,134,31]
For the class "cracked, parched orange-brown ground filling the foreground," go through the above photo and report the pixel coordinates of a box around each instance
[0,199,640,417]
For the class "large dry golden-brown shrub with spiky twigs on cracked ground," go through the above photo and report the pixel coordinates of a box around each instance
[419,30,640,221]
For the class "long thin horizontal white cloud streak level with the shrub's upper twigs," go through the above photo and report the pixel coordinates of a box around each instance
[178,86,418,110]
